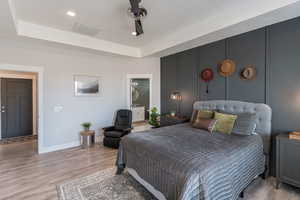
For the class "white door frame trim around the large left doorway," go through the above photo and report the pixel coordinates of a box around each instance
[0,63,45,154]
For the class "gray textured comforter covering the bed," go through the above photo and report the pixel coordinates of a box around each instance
[117,123,265,200]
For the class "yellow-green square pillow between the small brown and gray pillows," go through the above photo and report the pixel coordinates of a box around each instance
[214,112,237,134]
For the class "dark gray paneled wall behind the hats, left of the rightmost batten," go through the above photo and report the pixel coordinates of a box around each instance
[161,28,267,113]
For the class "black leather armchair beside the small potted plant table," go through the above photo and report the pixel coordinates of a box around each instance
[103,110,132,149]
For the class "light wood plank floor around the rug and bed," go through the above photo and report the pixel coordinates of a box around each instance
[0,142,300,200]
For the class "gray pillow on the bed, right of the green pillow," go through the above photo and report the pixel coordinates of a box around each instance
[221,111,257,135]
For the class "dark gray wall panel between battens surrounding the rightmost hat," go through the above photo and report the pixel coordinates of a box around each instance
[227,29,266,103]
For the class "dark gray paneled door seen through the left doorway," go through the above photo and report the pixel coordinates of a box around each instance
[1,78,33,139]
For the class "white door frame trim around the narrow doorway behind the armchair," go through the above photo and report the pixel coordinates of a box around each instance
[126,74,152,110]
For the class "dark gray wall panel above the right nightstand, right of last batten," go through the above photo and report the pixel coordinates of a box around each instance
[269,18,300,132]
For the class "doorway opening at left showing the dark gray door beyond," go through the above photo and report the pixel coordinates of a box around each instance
[0,70,37,148]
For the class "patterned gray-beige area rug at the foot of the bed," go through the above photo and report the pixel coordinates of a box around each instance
[57,168,156,200]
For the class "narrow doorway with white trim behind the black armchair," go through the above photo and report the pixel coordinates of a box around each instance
[127,74,152,123]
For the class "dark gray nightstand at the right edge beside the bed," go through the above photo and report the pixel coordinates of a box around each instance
[276,134,300,189]
